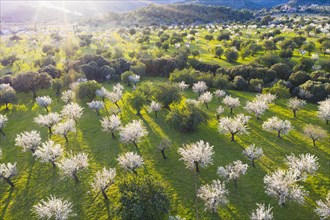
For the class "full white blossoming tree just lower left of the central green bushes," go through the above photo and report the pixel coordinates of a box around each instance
[119,120,148,148]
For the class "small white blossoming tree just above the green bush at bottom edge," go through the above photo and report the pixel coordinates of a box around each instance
[117,152,144,174]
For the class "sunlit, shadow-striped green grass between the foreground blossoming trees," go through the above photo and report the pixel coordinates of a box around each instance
[0,78,330,220]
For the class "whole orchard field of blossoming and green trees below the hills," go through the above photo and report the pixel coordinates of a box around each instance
[0,5,330,220]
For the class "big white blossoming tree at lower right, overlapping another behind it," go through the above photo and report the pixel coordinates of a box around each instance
[264,170,308,206]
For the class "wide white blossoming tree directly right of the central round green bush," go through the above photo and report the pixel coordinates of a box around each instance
[218,114,250,141]
